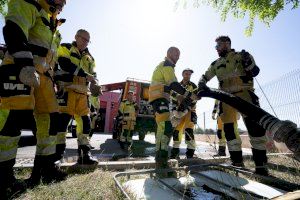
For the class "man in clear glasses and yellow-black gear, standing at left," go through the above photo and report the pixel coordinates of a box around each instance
[55,29,100,165]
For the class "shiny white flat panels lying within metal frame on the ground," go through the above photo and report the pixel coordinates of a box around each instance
[123,170,288,200]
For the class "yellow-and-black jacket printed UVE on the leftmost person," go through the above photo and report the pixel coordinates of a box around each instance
[0,0,62,109]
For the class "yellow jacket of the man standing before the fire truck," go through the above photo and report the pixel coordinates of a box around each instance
[119,99,137,121]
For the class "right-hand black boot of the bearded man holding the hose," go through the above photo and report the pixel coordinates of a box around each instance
[252,148,269,176]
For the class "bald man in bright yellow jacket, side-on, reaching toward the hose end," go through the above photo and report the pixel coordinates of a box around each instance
[149,47,197,172]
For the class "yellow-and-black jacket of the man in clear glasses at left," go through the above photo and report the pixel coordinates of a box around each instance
[56,42,96,94]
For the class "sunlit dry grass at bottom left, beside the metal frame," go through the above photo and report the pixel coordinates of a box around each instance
[17,169,123,200]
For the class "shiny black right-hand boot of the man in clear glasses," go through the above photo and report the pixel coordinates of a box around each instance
[77,145,98,165]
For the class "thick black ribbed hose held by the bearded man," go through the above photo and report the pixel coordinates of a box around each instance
[198,85,300,160]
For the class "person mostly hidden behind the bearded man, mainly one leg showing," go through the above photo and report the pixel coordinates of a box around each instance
[212,100,241,157]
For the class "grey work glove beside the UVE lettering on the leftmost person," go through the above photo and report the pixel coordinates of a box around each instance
[19,66,40,87]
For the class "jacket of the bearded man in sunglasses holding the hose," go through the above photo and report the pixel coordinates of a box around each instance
[202,50,259,94]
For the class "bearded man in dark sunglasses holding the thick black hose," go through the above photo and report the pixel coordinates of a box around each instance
[199,36,268,175]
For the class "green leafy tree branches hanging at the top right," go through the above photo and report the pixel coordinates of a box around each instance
[175,0,300,36]
